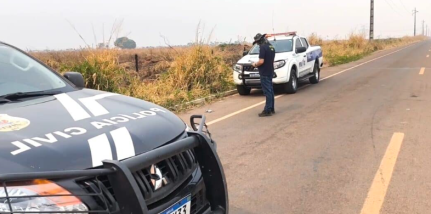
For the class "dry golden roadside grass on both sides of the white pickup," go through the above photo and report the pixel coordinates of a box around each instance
[31,34,425,111]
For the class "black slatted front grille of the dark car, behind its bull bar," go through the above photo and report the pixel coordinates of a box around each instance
[80,150,206,210]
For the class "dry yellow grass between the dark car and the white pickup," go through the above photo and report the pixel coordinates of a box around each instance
[32,44,236,110]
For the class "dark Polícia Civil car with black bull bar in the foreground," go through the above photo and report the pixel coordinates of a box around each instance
[0,42,228,214]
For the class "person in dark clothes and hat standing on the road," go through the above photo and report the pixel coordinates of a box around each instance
[252,33,275,117]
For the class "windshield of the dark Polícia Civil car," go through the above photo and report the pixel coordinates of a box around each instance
[0,44,66,96]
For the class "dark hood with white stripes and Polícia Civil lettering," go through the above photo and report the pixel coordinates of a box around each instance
[0,89,186,174]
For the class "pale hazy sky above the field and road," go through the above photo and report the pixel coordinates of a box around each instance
[0,0,431,50]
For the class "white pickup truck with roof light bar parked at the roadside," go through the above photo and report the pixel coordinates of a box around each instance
[233,32,323,95]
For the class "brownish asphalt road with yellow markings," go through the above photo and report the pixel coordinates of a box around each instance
[180,40,431,214]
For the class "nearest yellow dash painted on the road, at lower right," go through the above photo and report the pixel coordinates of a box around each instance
[361,132,404,214]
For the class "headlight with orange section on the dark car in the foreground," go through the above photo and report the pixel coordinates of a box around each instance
[0,180,88,213]
